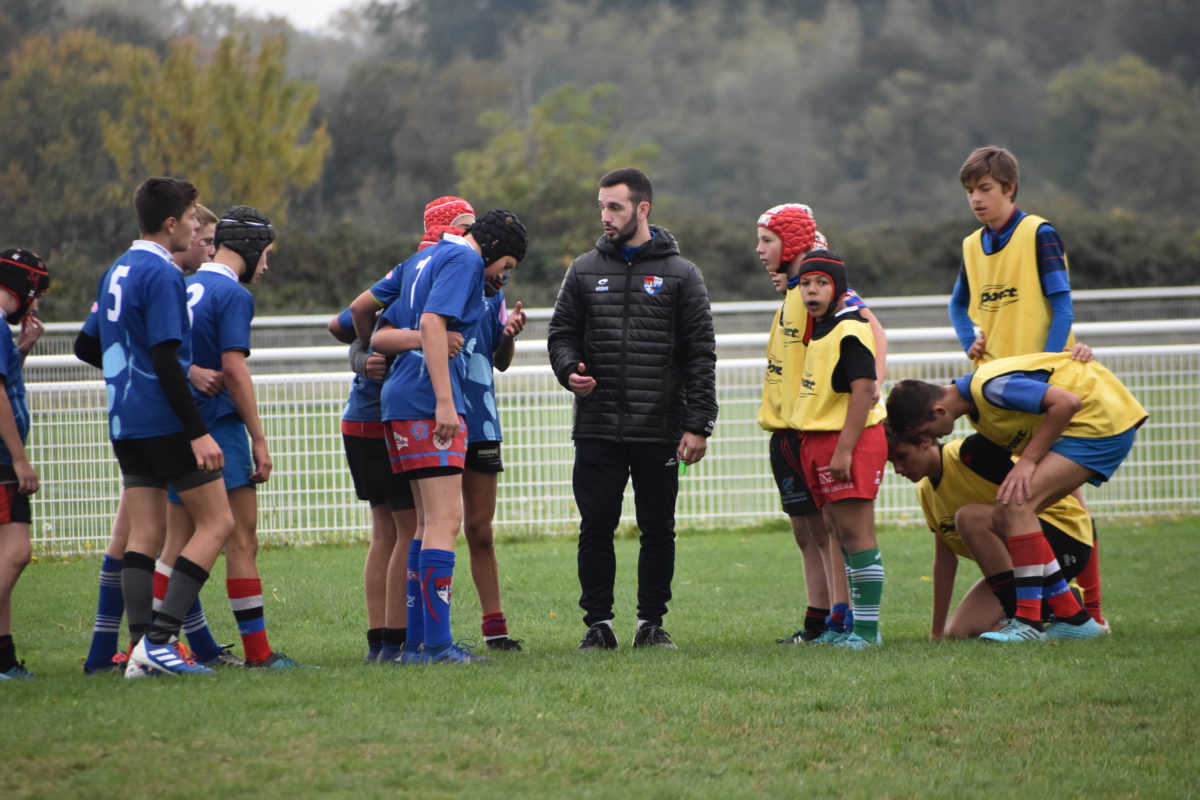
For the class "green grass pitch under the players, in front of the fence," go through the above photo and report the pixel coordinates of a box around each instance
[0,519,1200,799]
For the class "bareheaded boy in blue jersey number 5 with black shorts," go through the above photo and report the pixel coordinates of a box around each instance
[76,178,233,678]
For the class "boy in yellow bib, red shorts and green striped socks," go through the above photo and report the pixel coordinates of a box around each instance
[791,251,887,650]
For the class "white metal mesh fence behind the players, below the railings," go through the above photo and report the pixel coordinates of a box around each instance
[21,344,1200,553]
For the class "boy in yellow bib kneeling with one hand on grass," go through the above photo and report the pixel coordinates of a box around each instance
[888,433,1096,639]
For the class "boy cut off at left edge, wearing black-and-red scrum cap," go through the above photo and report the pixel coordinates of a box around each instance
[0,248,50,680]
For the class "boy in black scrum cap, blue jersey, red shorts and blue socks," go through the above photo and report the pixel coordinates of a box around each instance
[369,209,526,663]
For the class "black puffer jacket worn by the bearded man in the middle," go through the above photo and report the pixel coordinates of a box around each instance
[548,225,716,443]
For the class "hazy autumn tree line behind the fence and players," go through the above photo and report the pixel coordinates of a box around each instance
[0,0,1200,319]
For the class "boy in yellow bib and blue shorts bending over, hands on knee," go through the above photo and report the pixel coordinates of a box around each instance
[888,353,1147,642]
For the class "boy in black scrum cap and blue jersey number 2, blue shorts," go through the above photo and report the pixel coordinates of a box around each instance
[162,205,298,669]
